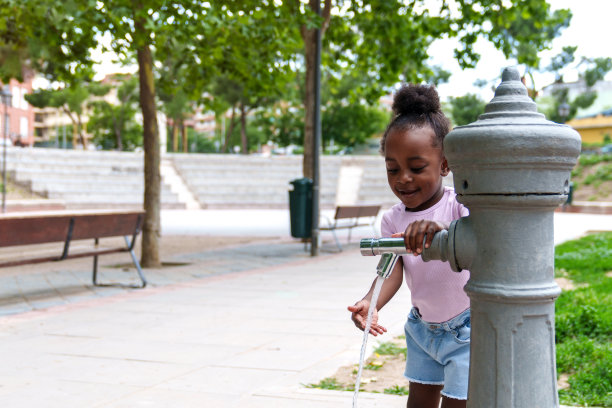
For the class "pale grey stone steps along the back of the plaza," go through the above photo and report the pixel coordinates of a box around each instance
[2,147,452,209]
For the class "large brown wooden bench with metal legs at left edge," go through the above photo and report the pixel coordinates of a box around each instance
[0,210,147,288]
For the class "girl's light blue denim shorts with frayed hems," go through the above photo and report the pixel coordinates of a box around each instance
[404,308,470,400]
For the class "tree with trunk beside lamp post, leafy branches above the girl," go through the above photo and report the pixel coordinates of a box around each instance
[282,0,571,177]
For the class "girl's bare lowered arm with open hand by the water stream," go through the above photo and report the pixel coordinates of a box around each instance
[348,258,404,336]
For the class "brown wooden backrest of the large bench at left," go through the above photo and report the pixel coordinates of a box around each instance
[0,211,144,247]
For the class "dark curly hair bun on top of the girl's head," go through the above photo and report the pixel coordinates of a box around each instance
[392,84,440,116]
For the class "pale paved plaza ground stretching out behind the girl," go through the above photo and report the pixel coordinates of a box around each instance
[0,211,612,408]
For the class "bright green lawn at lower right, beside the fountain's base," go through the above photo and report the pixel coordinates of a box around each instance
[555,233,612,407]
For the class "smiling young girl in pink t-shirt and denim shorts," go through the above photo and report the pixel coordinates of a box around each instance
[348,85,470,408]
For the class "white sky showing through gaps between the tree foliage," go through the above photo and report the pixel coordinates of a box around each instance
[88,0,612,101]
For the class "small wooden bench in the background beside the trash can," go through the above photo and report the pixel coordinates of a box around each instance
[319,205,381,251]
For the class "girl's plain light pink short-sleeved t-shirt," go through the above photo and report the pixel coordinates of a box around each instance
[381,187,470,323]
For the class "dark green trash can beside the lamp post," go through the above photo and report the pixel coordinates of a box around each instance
[289,177,312,238]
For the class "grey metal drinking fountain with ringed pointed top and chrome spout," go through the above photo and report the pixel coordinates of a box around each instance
[361,68,581,408]
